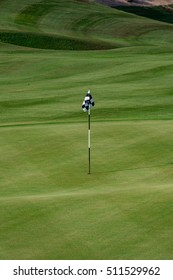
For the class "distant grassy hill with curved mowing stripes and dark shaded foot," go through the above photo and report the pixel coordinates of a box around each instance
[0,0,172,50]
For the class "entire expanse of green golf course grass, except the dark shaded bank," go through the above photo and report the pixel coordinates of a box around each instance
[0,0,173,259]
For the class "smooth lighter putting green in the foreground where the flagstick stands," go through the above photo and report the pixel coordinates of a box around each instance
[0,121,173,259]
